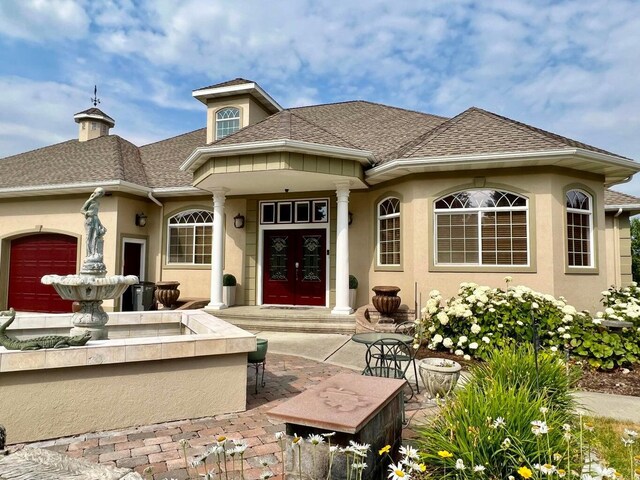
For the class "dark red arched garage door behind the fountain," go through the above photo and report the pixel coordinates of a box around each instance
[8,234,78,313]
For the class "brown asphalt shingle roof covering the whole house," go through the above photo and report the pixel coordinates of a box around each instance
[0,94,638,193]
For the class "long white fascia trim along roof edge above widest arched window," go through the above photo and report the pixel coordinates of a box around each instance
[365,148,640,178]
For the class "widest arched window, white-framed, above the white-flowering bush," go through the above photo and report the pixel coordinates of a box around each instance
[435,190,529,266]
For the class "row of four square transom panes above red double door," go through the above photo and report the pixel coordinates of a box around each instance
[260,198,329,225]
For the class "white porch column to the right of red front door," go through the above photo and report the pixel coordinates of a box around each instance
[331,182,352,315]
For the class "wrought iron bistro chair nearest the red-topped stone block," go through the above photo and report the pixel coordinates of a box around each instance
[362,338,415,398]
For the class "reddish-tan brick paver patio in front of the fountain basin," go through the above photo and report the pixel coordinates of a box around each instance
[20,354,430,480]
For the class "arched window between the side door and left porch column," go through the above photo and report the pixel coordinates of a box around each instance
[167,210,213,265]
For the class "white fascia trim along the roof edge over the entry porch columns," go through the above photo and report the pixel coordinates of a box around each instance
[180,139,373,172]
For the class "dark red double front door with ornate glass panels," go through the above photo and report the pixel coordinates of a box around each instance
[262,229,327,306]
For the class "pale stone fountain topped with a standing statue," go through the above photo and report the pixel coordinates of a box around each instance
[41,187,138,340]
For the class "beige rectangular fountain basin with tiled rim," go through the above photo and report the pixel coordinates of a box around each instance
[0,310,256,443]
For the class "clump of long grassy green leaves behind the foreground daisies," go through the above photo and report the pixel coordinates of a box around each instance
[418,349,575,478]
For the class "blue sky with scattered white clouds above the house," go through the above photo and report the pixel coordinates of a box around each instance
[0,0,640,196]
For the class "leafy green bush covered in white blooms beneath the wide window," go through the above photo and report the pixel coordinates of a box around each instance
[422,277,640,369]
